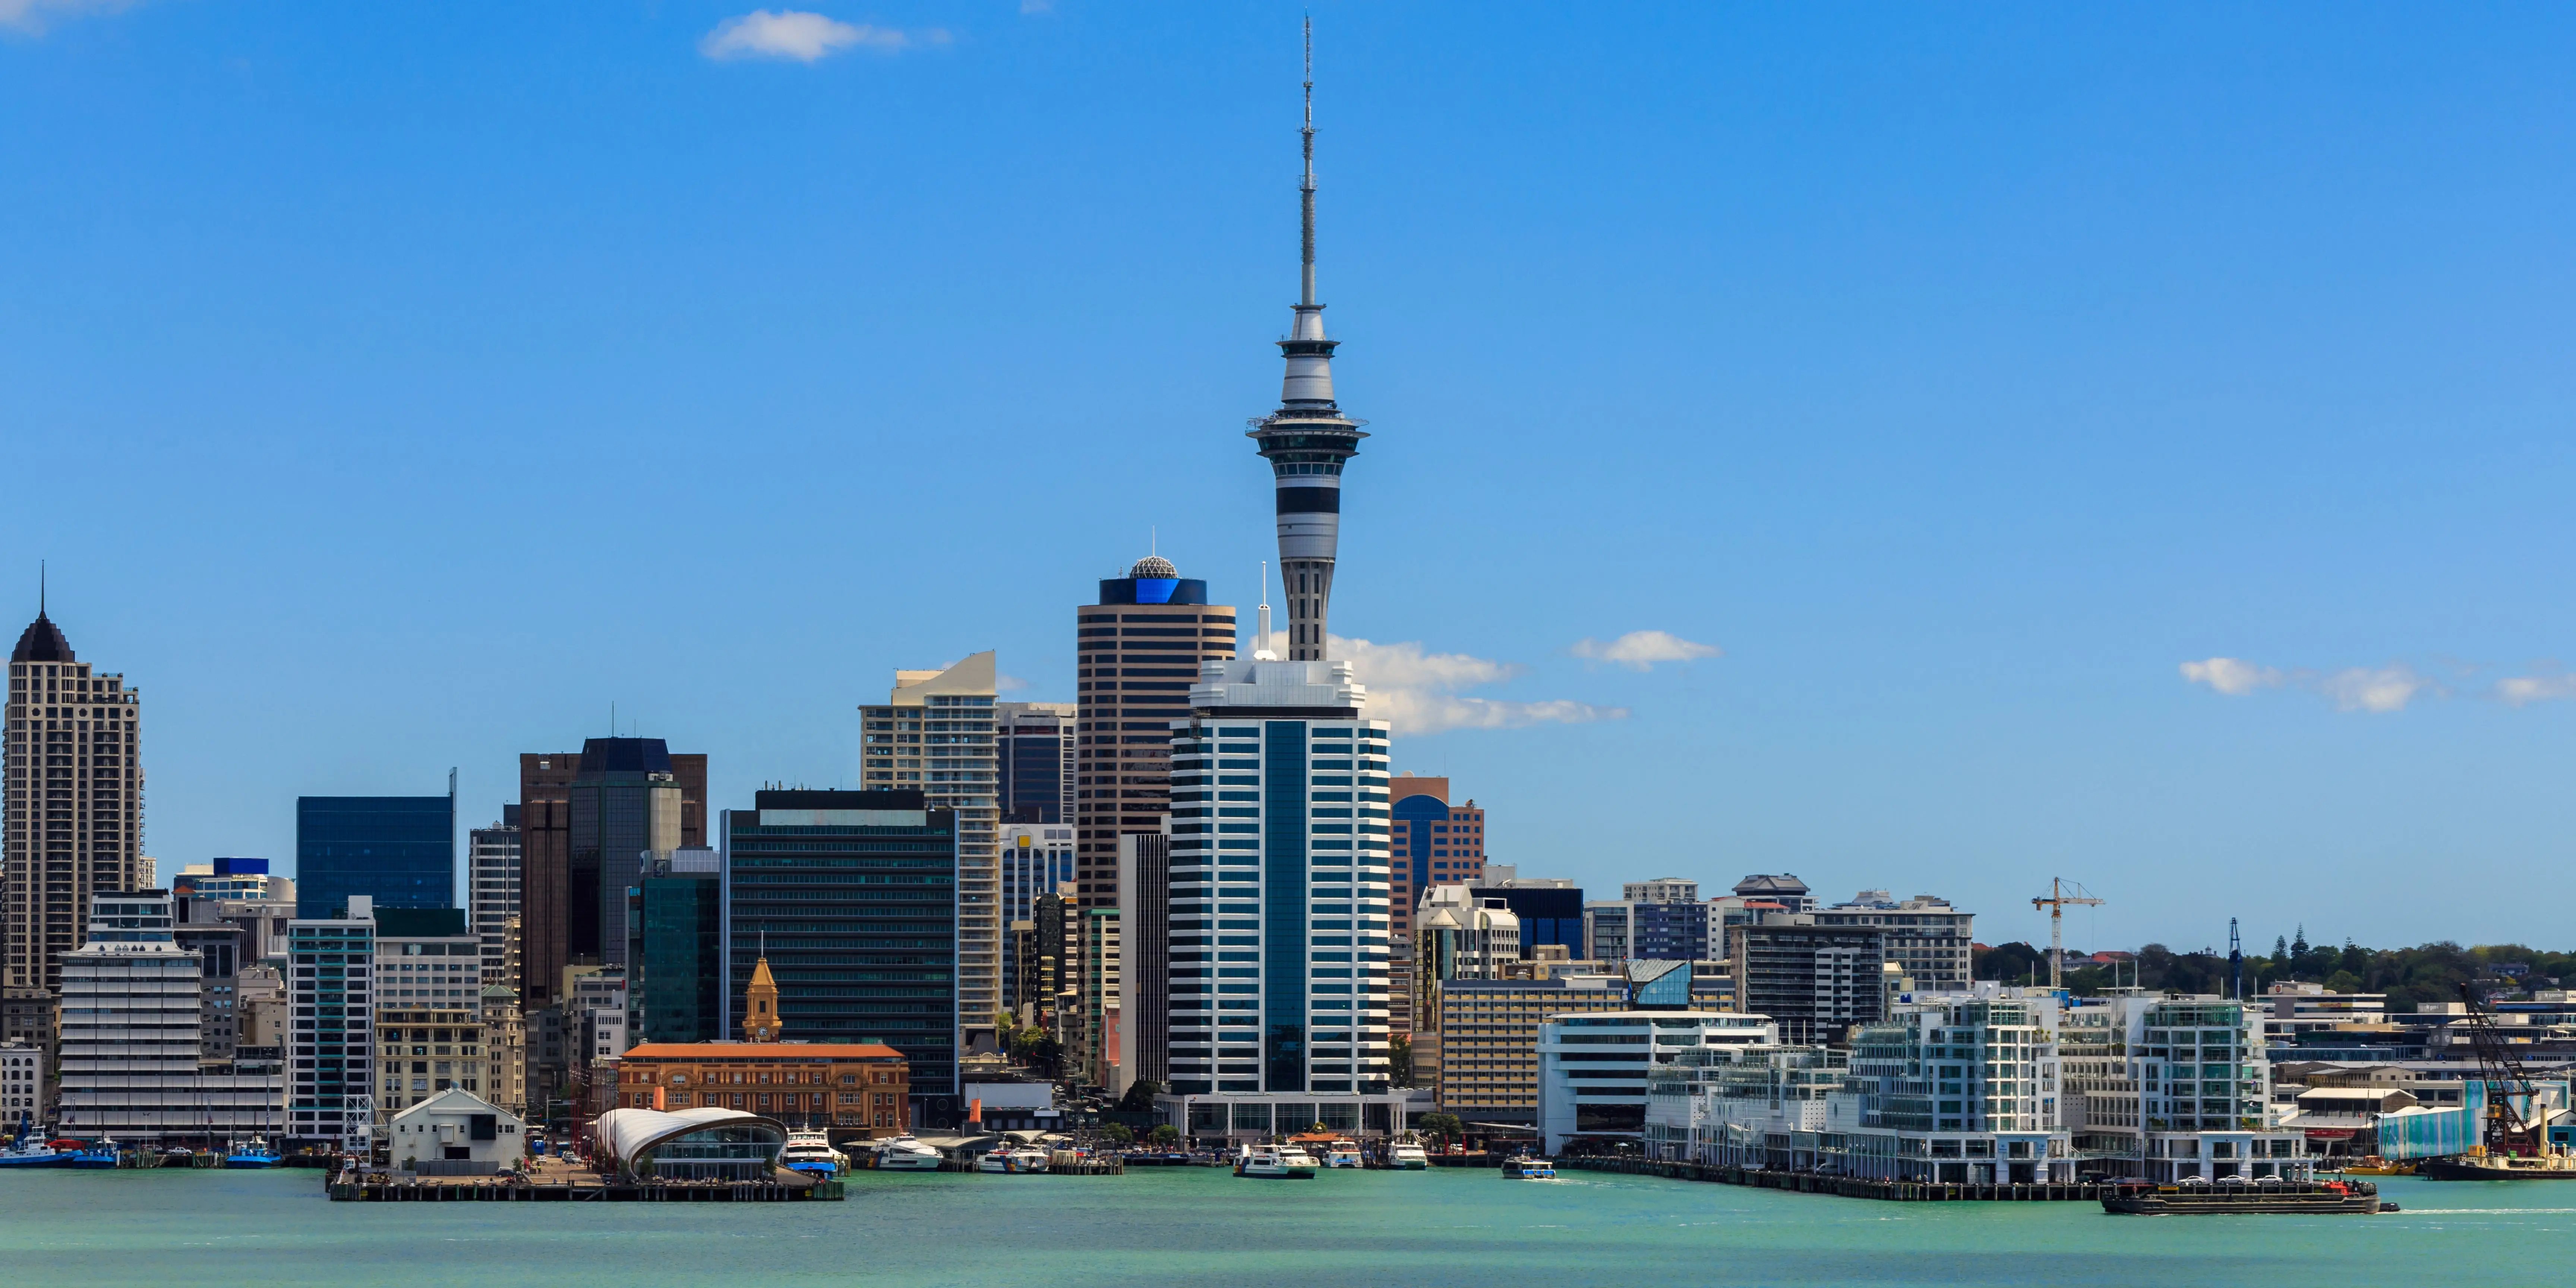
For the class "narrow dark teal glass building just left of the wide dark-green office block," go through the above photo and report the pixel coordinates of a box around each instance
[626,845,724,1043]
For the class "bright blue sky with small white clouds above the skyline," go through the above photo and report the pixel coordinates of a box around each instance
[0,0,2576,948]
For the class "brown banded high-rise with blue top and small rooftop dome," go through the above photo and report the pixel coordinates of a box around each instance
[1071,556,1234,907]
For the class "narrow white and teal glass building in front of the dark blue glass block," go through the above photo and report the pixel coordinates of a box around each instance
[286,894,376,1149]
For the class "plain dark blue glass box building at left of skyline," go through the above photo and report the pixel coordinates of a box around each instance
[296,783,456,920]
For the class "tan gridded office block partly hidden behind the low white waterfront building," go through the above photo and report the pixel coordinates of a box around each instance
[1414,974,1628,1126]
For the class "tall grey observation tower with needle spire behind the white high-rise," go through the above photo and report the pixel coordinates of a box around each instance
[1249,18,1368,662]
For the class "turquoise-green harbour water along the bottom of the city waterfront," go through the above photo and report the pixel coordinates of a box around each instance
[0,1167,2576,1288]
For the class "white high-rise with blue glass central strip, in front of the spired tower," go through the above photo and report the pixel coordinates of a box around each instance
[1169,659,1401,1133]
